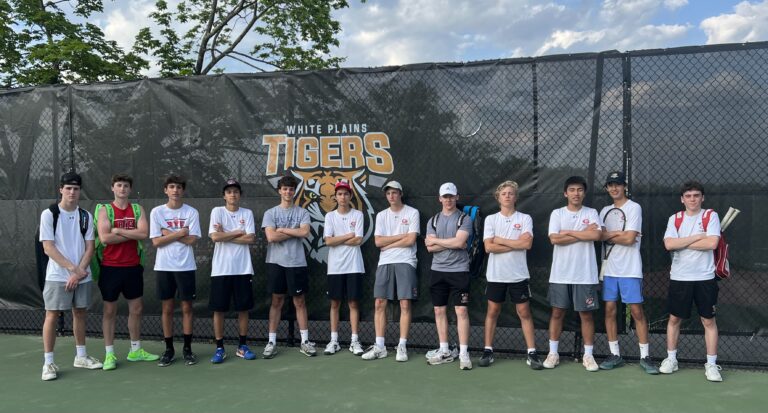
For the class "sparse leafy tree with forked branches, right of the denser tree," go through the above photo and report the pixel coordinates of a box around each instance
[135,0,356,77]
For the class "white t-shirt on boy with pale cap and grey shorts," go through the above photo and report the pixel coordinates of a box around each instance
[374,205,421,268]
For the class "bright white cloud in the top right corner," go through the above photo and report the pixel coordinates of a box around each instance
[699,1,768,44]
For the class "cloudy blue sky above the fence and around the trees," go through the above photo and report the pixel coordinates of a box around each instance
[91,0,768,77]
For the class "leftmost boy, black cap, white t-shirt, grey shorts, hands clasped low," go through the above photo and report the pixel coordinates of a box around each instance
[40,172,103,381]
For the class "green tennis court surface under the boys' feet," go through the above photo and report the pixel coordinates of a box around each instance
[0,335,768,413]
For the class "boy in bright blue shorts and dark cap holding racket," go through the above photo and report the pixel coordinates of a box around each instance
[600,171,659,374]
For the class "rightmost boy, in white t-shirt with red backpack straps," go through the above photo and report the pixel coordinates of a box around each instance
[659,181,723,381]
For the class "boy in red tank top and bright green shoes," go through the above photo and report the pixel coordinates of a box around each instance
[95,174,160,370]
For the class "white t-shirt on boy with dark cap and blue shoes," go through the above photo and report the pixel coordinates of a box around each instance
[208,206,256,277]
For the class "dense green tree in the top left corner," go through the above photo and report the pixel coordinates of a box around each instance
[0,0,149,87]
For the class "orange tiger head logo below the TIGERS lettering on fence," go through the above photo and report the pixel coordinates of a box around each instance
[290,169,374,262]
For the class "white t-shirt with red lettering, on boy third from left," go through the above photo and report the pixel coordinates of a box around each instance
[149,204,201,271]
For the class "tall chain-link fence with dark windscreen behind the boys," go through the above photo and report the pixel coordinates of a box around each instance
[0,43,768,367]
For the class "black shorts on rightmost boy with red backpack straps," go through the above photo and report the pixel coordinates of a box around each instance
[667,278,719,318]
